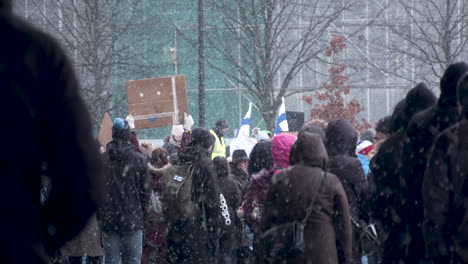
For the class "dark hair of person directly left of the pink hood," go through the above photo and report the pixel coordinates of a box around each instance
[247,141,273,175]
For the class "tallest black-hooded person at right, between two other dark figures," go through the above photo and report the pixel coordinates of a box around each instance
[401,62,468,263]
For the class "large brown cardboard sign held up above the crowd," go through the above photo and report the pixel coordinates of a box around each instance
[127,75,188,129]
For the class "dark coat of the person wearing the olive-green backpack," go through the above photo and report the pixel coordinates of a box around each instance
[167,145,224,263]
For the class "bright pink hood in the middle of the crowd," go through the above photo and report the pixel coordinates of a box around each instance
[271,133,296,168]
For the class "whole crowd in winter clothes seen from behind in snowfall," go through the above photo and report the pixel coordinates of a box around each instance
[0,0,468,264]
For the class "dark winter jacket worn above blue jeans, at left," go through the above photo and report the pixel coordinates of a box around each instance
[97,140,150,233]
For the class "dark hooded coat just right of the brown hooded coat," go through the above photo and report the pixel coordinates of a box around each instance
[326,119,369,263]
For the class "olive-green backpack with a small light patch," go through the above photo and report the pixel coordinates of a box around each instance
[161,164,196,222]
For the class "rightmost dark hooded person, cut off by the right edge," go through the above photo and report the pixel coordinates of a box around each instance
[422,74,468,264]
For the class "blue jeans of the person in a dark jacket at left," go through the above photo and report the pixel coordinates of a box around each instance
[102,230,143,264]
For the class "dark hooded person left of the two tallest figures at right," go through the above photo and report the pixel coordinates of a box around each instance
[369,83,437,263]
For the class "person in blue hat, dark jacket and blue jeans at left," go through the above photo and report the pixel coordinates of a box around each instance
[97,118,151,263]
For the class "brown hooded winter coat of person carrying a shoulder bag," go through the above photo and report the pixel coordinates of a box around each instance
[262,132,352,264]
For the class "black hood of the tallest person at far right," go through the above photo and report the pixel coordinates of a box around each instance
[438,62,468,106]
